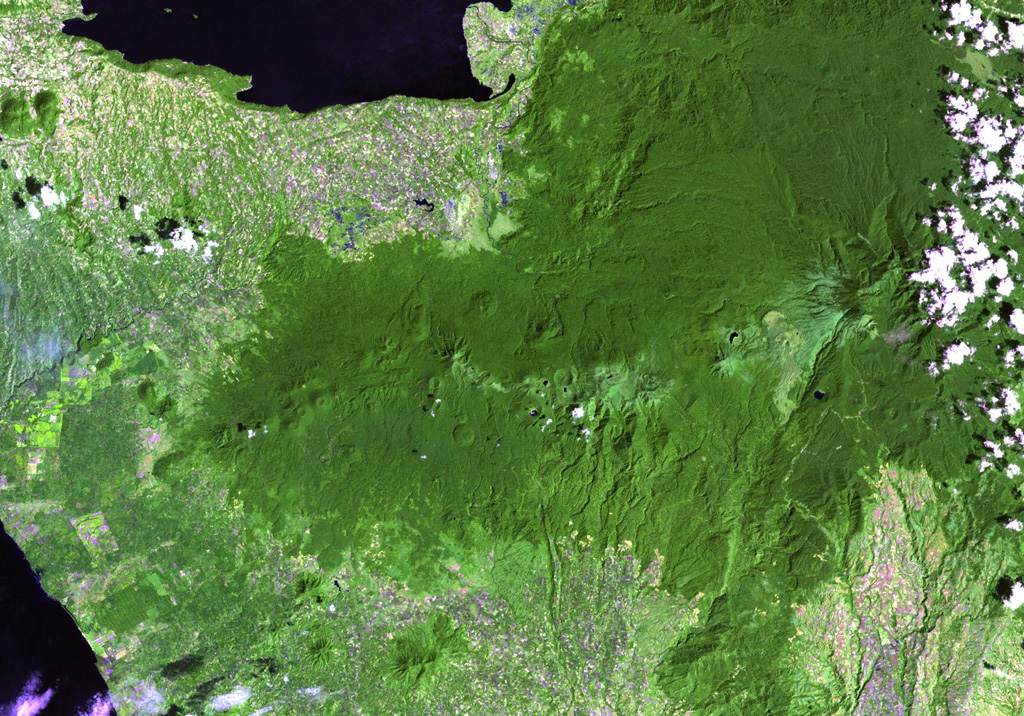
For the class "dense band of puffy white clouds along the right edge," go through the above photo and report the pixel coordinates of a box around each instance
[910,0,1024,475]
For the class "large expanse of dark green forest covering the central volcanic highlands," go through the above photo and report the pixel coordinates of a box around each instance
[167,2,1024,713]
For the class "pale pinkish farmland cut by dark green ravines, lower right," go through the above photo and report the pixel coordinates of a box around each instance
[795,465,1005,716]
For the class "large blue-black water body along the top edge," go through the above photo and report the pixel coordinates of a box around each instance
[65,0,511,112]
